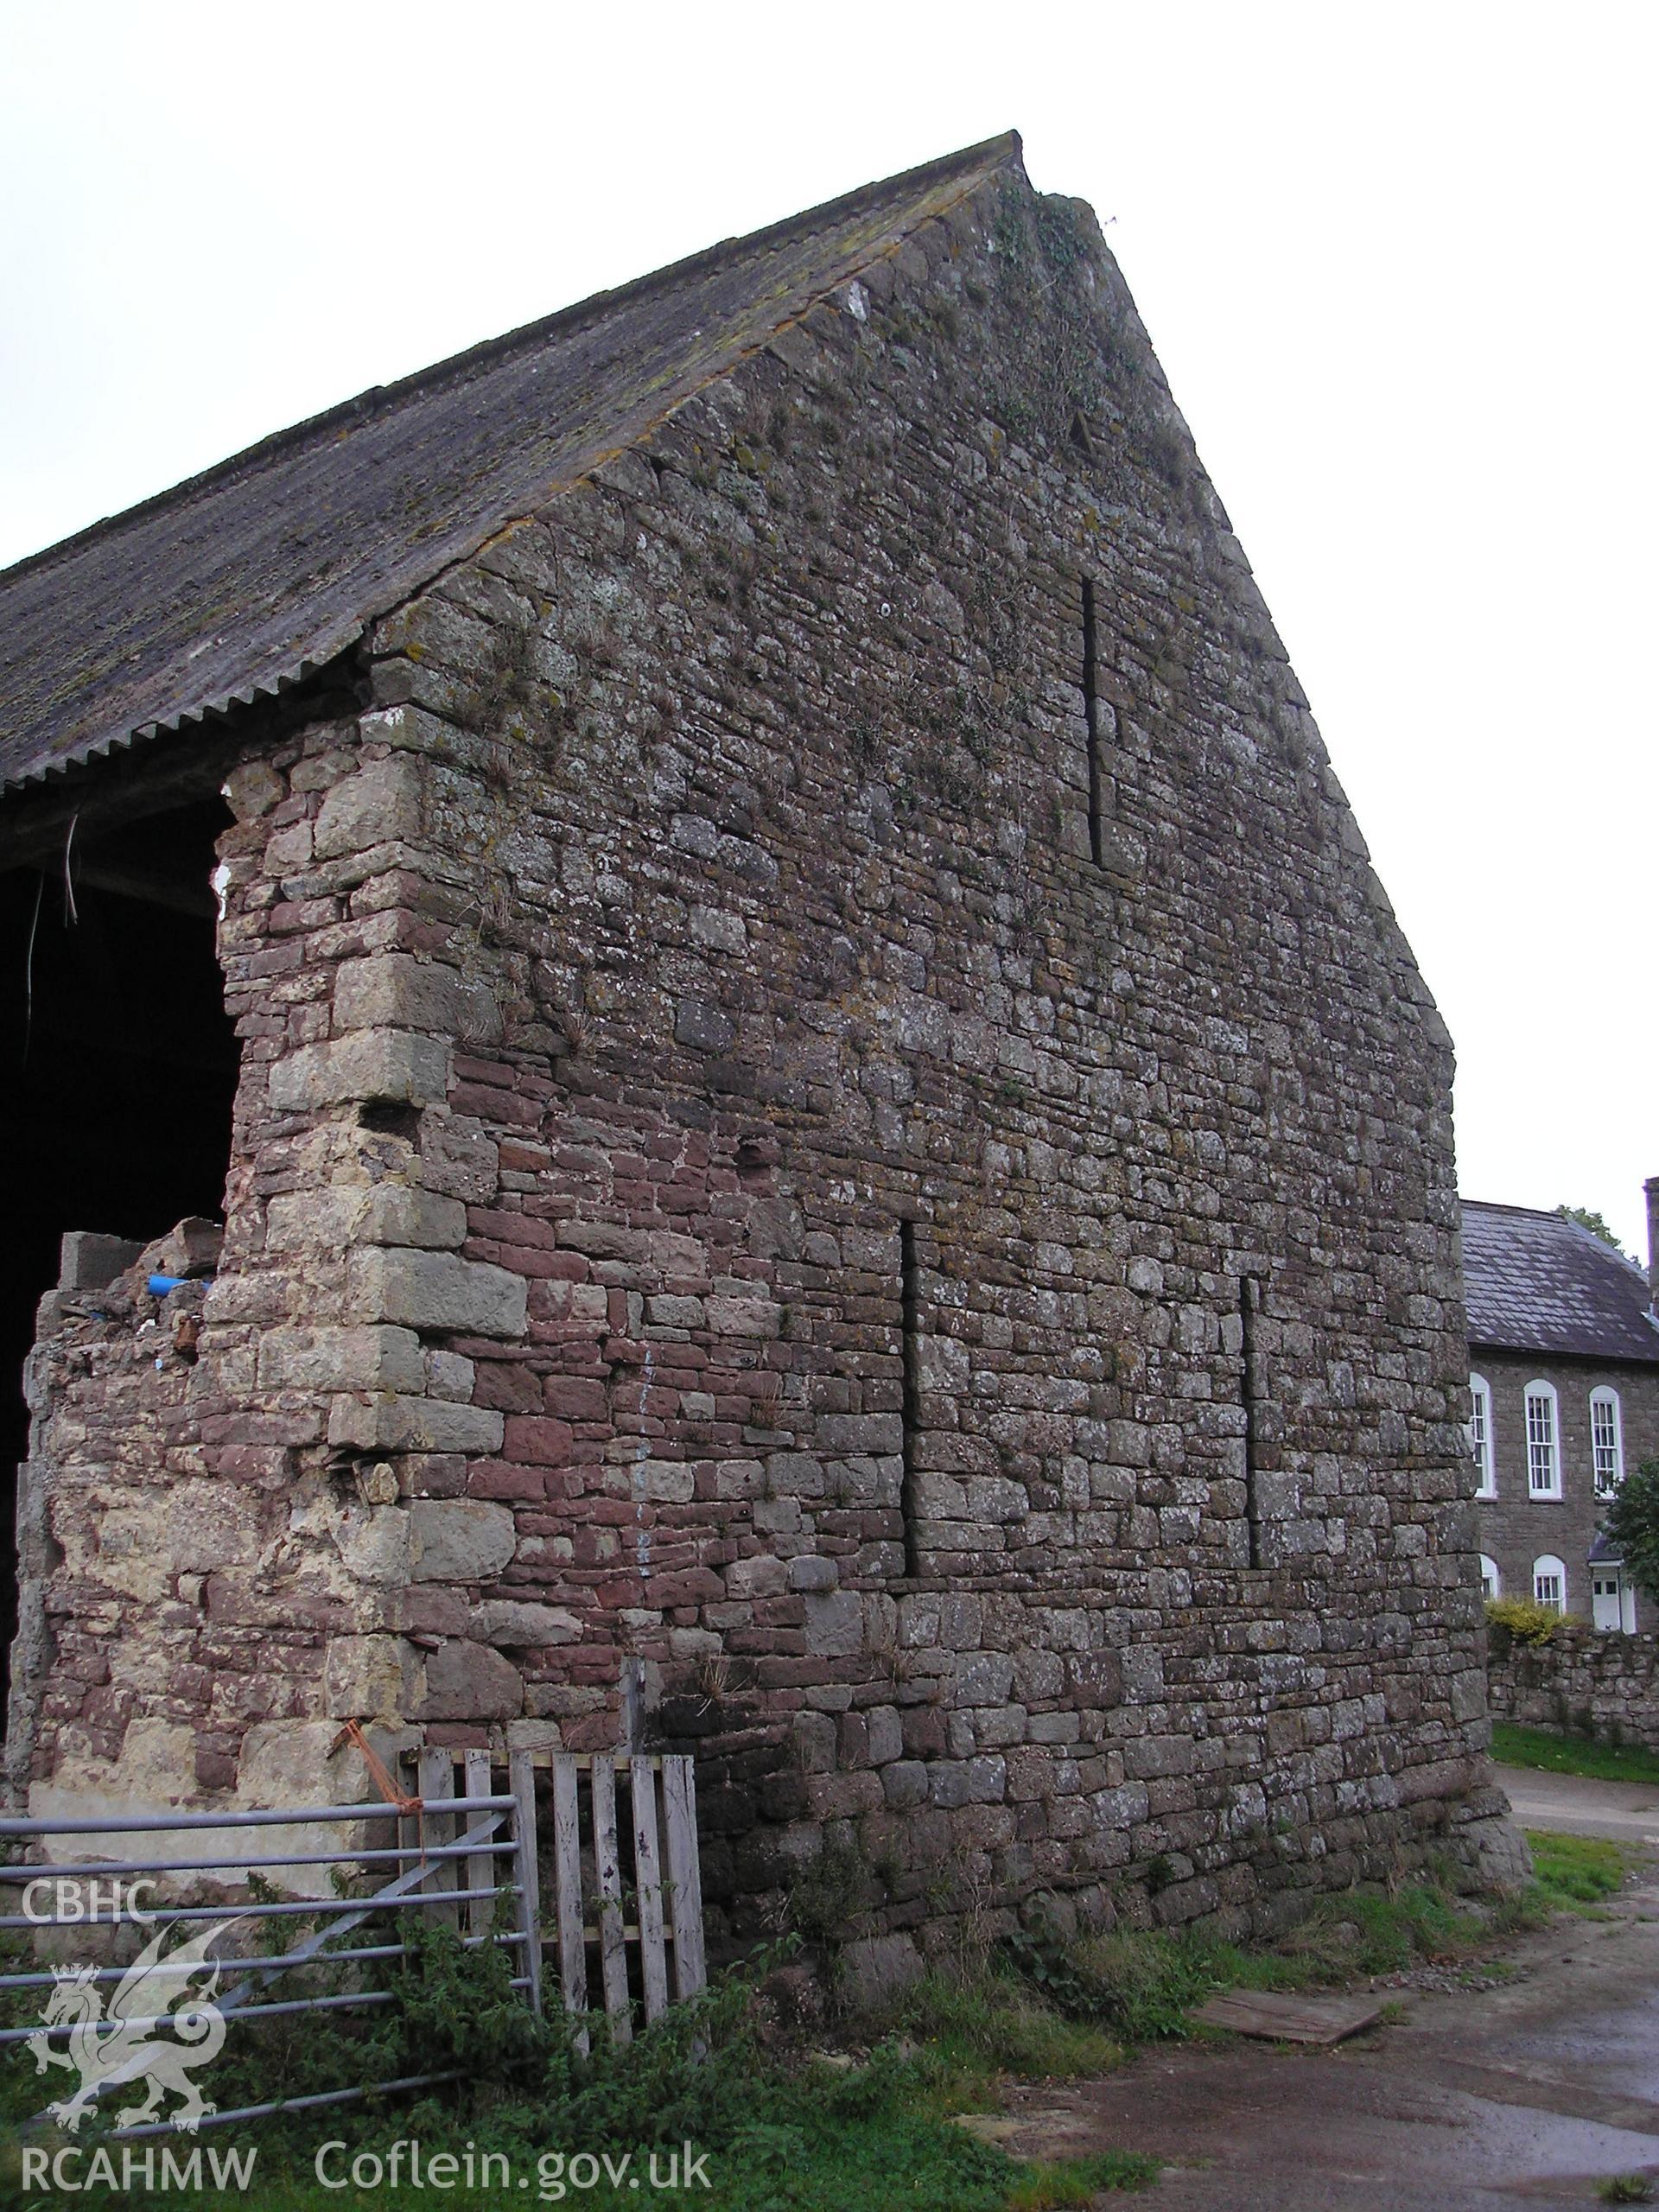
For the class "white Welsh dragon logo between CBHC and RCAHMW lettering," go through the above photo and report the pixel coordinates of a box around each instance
[29,1923,234,2134]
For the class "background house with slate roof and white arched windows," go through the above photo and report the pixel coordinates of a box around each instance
[1462,1177,1659,1632]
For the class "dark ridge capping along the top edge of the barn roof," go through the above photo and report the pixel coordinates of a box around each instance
[0,130,1024,584]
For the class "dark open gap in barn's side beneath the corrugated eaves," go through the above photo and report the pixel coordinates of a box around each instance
[0,798,238,1688]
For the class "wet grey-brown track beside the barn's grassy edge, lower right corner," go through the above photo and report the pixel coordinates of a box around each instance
[1007,1872,1659,2212]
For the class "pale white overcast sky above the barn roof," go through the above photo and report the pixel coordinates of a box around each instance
[0,0,1659,1259]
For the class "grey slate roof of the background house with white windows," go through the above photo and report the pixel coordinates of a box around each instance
[1462,1199,1659,1365]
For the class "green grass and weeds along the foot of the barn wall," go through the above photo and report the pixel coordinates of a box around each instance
[0,1834,1635,2212]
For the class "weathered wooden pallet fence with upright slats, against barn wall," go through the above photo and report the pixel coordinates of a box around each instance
[418,1750,708,2049]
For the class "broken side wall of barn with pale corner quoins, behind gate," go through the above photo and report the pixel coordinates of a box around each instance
[7,723,575,1809]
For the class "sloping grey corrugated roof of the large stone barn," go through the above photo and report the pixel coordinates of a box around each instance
[0,133,1020,783]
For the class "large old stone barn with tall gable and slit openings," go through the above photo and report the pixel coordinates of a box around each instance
[0,137,1513,1951]
